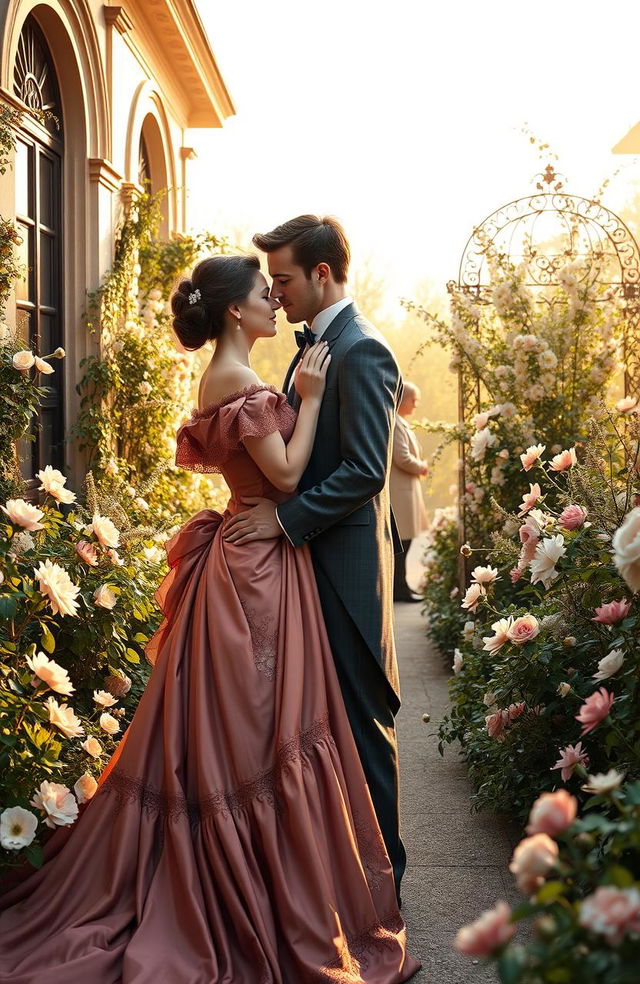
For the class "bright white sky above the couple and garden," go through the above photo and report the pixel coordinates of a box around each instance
[189,0,640,316]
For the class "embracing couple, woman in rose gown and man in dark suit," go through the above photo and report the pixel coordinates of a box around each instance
[0,216,419,984]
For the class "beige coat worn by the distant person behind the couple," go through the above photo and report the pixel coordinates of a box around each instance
[389,414,427,540]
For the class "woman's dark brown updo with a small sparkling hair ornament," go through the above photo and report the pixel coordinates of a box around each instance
[171,256,260,351]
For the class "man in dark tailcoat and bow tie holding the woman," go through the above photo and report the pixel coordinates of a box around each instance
[225,215,406,898]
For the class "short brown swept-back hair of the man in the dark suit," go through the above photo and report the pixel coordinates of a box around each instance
[253,215,351,284]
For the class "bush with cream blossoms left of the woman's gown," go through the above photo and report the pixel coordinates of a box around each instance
[0,468,167,870]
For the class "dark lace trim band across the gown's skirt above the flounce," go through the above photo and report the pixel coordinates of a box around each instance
[99,717,333,825]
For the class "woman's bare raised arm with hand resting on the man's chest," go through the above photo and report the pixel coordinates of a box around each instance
[244,341,331,492]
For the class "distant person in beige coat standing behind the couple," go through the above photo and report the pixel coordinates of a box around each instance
[389,382,429,601]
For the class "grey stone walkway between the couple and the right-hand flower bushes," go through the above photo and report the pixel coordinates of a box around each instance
[395,603,522,984]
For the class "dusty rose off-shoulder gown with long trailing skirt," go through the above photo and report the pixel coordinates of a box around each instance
[0,385,419,984]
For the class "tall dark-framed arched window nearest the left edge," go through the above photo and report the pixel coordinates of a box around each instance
[13,15,64,484]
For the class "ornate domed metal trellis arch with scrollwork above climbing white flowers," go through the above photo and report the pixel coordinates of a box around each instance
[450,165,640,587]
